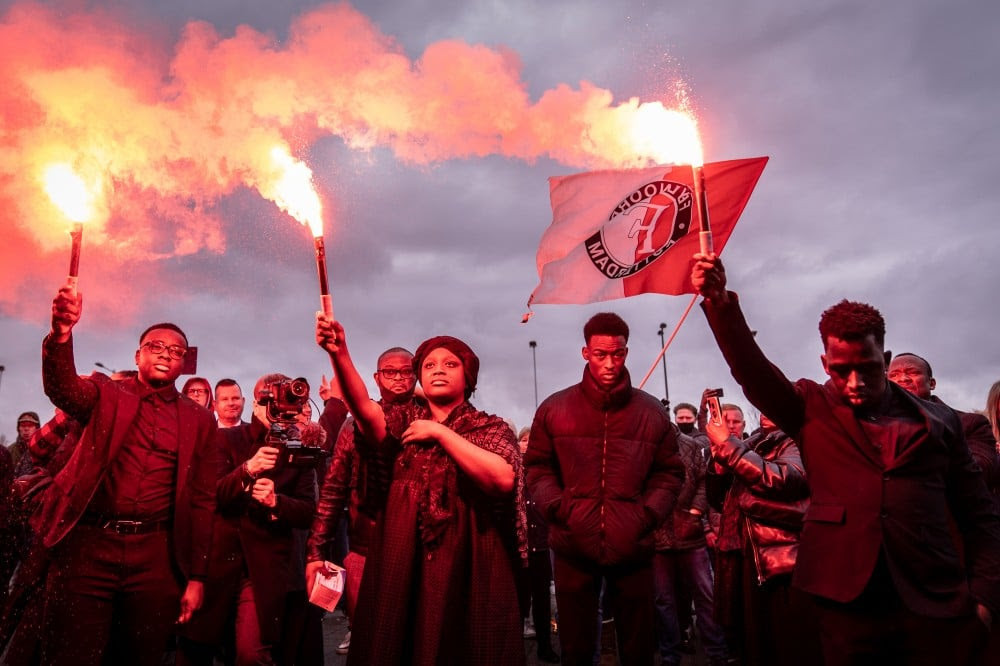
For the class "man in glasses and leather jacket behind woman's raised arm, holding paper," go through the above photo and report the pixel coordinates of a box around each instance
[305,347,417,654]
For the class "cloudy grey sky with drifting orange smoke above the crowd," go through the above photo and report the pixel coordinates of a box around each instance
[0,0,1000,438]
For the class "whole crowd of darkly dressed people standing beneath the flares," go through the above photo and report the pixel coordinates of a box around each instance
[0,250,1000,666]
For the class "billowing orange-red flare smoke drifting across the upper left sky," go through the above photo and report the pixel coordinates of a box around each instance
[0,3,696,314]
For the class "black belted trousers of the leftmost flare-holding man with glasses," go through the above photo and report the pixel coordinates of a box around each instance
[42,525,181,666]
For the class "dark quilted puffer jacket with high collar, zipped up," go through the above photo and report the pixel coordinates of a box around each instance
[524,368,684,565]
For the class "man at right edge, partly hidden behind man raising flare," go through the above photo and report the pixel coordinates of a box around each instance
[888,352,1000,492]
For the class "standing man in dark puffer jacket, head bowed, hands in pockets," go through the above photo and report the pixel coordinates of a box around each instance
[524,312,684,665]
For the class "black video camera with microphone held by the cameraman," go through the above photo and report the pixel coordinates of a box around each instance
[257,377,326,468]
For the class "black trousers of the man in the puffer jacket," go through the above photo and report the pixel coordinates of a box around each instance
[554,553,656,666]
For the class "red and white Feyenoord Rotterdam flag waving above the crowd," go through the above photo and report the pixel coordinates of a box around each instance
[528,157,767,306]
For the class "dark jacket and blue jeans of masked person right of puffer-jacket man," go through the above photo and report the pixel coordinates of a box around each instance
[653,420,727,666]
